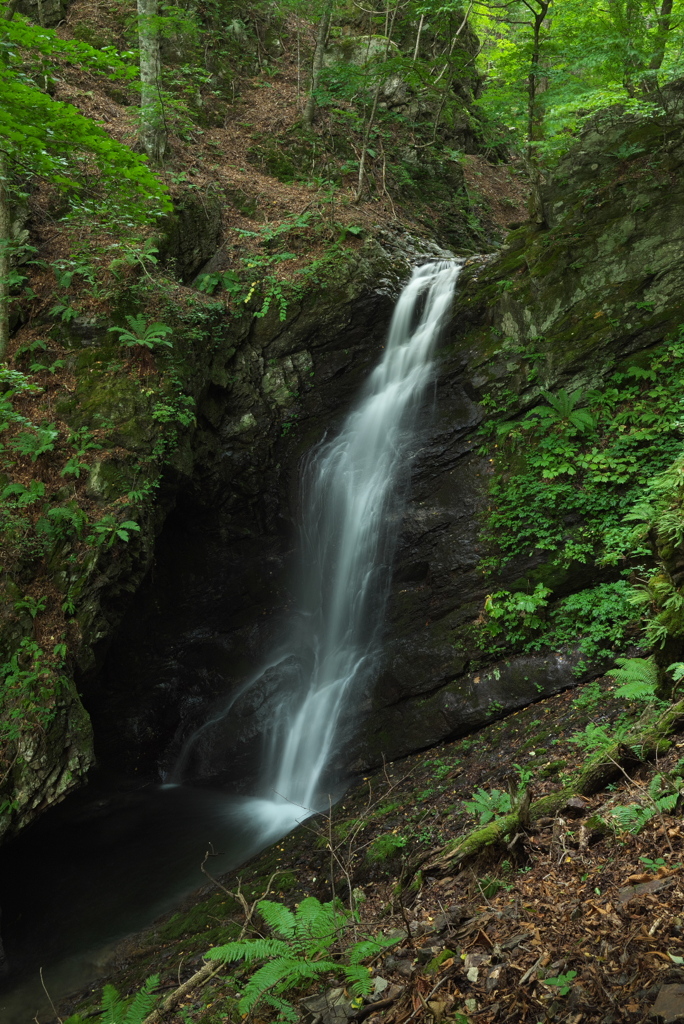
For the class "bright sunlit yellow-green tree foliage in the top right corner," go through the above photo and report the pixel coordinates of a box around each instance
[471,0,682,164]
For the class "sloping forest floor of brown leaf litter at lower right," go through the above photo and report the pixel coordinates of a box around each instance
[57,679,684,1024]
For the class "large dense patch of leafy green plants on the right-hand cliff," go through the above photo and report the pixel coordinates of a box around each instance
[482,335,684,571]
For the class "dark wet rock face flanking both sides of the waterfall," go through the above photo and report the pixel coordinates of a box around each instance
[69,96,684,774]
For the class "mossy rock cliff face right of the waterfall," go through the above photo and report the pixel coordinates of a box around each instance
[364,94,684,759]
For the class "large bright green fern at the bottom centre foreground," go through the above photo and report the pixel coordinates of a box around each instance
[206,896,394,1021]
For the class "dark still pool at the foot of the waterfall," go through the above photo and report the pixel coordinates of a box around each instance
[0,786,278,1024]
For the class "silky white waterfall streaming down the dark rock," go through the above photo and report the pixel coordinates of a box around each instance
[174,261,461,838]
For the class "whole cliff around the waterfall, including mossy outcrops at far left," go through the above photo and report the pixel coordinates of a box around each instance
[5,90,684,828]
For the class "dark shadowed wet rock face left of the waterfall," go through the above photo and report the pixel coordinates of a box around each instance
[89,238,413,777]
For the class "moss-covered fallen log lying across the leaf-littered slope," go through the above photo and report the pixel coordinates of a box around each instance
[422,700,684,872]
